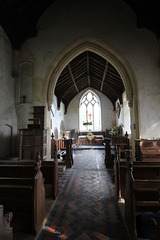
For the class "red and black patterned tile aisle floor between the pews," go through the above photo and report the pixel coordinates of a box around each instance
[38,150,129,240]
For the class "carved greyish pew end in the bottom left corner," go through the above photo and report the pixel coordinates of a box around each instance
[0,205,13,240]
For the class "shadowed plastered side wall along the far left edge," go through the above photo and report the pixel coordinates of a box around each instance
[0,27,17,158]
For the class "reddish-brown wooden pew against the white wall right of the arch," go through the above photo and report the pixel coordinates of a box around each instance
[135,139,160,162]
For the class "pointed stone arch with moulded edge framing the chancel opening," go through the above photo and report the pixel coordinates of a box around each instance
[45,37,139,158]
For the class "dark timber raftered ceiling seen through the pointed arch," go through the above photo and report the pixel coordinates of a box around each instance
[55,51,124,111]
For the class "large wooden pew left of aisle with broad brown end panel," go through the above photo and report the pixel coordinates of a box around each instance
[0,160,45,233]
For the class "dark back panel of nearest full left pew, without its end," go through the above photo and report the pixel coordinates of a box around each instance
[0,177,34,232]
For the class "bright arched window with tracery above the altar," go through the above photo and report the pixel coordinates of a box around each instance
[79,90,101,131]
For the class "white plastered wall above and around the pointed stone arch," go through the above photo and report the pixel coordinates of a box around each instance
[17,0,160,144]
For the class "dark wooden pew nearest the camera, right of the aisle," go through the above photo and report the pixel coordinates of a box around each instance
[125,162,160,239]
